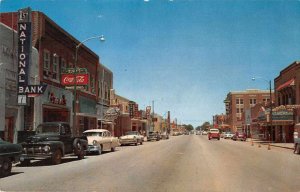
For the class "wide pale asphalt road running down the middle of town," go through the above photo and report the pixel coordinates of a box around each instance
[0,135,300,192]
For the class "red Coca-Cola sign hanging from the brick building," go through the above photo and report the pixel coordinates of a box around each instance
[61,74,89,86]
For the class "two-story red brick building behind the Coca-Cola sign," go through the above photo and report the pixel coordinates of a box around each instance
[0,11,113,134]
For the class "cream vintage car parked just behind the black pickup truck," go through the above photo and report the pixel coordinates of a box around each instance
[83,129,120,155]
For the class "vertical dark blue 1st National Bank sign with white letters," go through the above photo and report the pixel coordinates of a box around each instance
[17,8,46,105]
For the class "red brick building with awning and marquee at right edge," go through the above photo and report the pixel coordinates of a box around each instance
[273,61,300,142]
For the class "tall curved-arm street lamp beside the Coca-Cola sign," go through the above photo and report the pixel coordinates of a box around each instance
[73,35,105,135]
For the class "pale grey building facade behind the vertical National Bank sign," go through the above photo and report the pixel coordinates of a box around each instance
[0,23,39,143]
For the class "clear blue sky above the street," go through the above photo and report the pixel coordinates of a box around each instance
[0,0,300,126]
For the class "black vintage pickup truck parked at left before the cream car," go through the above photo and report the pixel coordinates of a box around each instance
[20,122,88,166]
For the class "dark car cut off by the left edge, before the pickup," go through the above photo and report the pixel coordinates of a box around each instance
[0,139,22,177]
